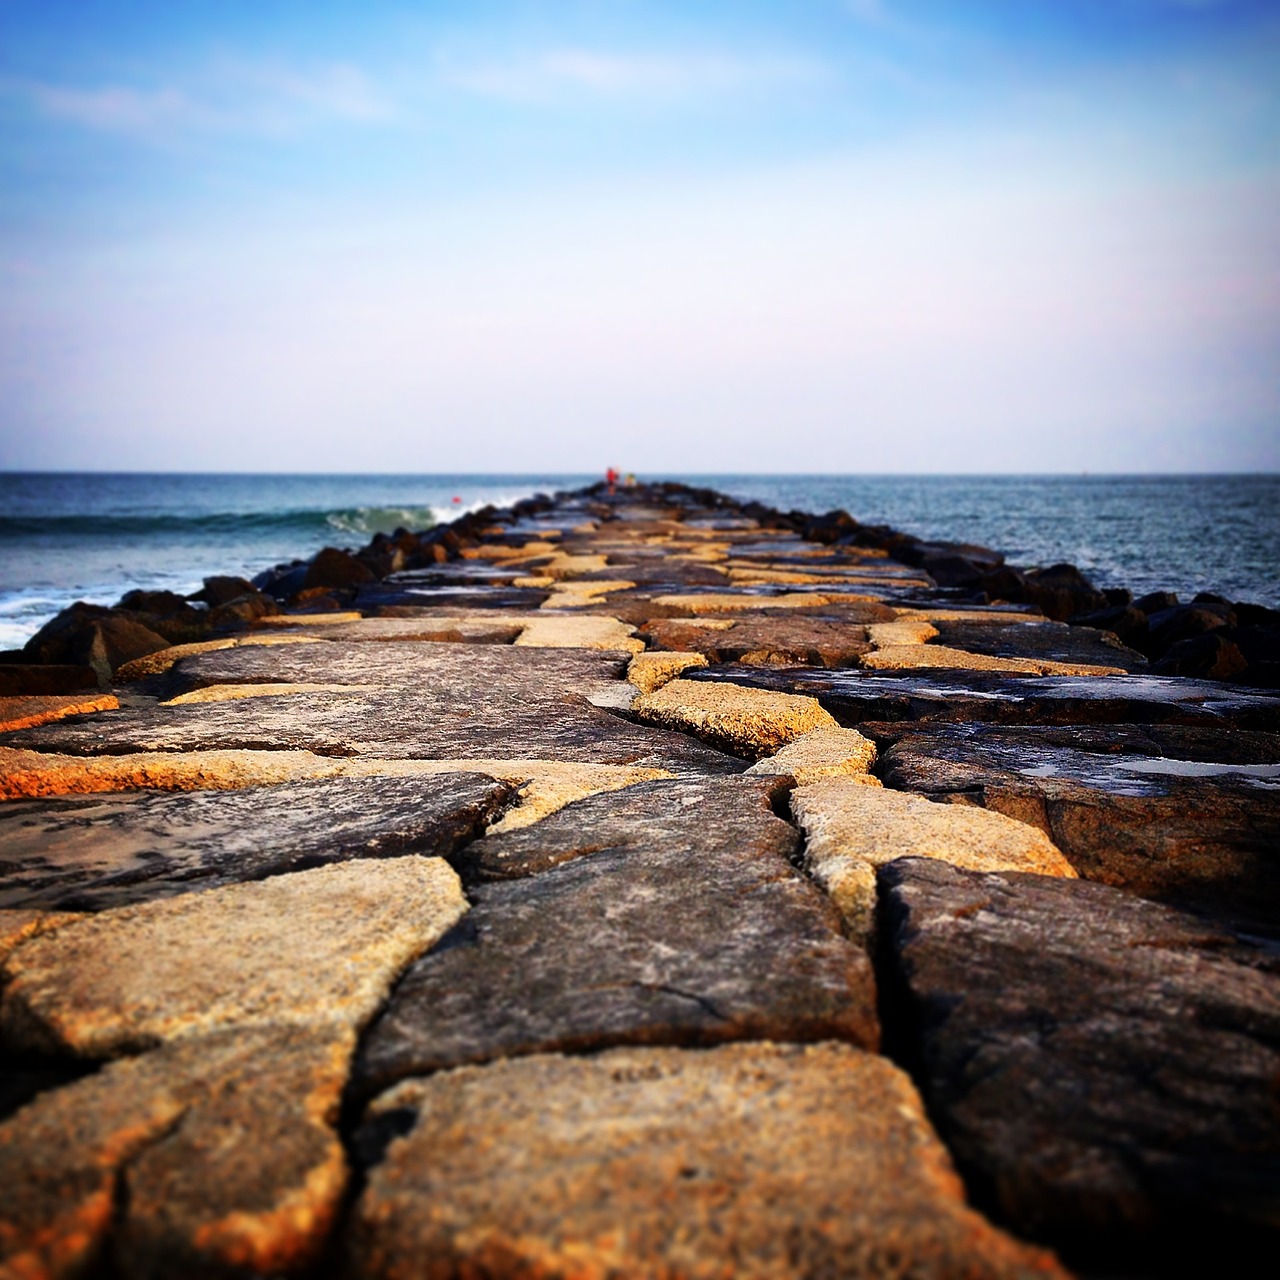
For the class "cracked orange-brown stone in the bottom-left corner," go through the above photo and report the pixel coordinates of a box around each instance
[0,1028,353,1277]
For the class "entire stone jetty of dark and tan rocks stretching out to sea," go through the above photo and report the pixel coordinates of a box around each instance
[0,484,1280,1280]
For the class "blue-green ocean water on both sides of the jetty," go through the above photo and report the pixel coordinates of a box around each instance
[0,472,1280,649]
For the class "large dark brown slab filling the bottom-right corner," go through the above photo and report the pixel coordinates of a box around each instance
[881,859,1280,1274]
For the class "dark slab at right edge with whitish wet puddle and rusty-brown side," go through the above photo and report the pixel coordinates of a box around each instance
[884,724,1280,936]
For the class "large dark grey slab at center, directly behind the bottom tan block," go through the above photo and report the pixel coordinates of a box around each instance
[355,778,877,1096]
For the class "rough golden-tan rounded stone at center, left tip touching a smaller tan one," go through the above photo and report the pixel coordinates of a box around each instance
[631,680,838,759]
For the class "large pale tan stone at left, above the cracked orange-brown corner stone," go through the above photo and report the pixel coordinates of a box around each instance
[0,855,467,1057]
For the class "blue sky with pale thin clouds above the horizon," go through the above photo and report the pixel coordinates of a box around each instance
[0,0,1280,474]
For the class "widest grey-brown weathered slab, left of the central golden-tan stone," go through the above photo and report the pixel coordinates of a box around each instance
[6,641,737,771]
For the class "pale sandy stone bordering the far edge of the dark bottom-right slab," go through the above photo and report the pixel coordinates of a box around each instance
[791,778,1075,878]
